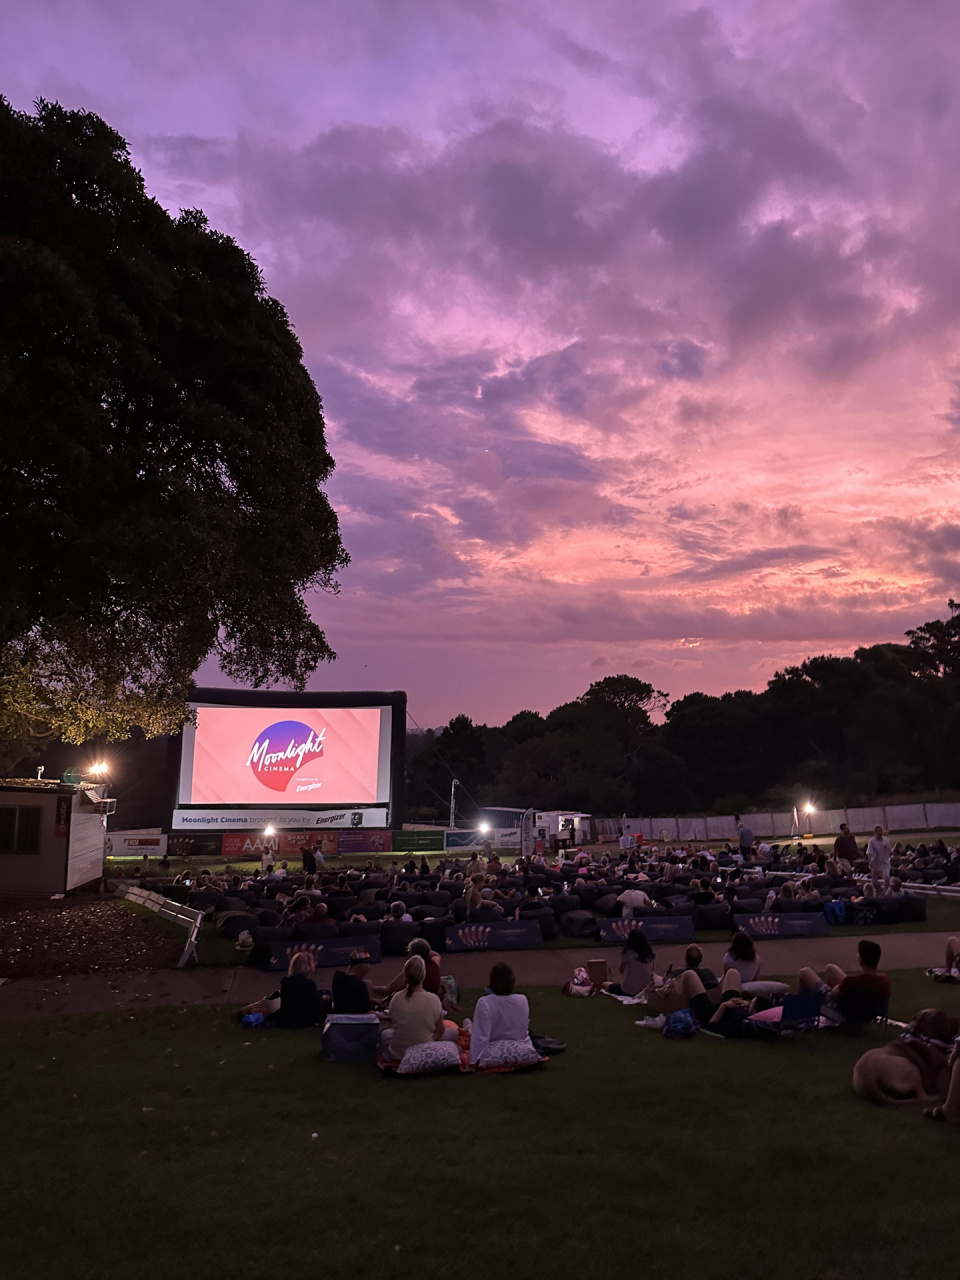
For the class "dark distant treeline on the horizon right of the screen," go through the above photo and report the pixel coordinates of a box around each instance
[407,600,960,822]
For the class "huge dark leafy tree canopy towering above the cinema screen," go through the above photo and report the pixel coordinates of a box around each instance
[0,99,348,755]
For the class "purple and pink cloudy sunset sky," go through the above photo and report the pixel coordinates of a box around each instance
[7,0,960,724]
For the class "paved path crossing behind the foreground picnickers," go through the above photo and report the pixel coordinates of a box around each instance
[0,933,950,1016]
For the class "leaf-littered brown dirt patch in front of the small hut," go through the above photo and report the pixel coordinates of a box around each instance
[0,899,183,978]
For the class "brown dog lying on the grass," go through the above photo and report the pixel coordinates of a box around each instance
[854,1009,960,1107]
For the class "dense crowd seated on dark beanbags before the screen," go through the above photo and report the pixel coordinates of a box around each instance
[140,832,960,955]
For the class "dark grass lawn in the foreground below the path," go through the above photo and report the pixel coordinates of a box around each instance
[0,973,960,1280]
